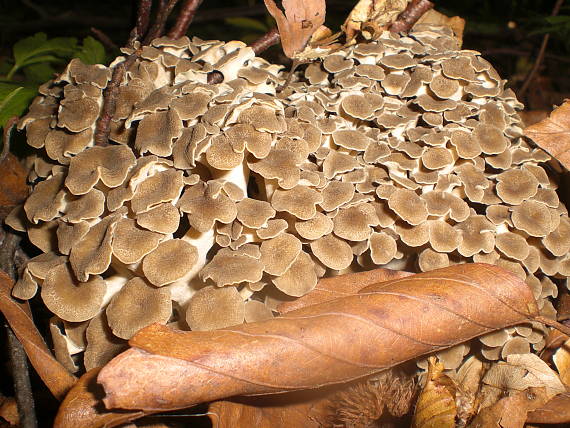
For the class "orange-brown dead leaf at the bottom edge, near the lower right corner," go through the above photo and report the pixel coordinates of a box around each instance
[469,388,548,428]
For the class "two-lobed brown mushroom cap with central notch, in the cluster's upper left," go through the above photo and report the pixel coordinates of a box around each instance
[65,145,136,195]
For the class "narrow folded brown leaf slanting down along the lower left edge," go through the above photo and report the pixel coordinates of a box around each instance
[0,271,76,400]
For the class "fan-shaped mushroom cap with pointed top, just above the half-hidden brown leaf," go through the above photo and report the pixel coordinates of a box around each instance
[272,251,317,297]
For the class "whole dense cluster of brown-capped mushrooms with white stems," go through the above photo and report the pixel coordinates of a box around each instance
[7,25,570,370]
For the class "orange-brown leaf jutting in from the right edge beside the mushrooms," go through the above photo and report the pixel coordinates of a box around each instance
[524,101,570,169]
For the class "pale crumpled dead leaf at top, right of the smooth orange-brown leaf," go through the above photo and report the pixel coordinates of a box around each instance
[341,0,408,43]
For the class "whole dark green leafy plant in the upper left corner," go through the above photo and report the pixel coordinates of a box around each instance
[0,33,105,134]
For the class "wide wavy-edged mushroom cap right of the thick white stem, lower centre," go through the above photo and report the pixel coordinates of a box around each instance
[200,249,263,287]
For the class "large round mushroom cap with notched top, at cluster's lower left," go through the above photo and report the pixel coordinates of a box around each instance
[41,263,107,322]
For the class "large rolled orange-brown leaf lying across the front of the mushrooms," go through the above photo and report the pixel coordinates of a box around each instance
[98,264,538,410]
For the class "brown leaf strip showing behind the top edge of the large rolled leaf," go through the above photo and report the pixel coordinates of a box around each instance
[277,268,413,314]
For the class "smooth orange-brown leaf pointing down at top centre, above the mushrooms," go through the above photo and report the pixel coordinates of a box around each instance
[264,0,326,58]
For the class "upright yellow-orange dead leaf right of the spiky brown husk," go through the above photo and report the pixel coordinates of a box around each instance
[412,357,457,428]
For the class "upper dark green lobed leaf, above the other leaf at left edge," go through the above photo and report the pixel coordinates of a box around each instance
[7,33,77,79]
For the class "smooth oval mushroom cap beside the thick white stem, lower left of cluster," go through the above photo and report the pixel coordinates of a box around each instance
[142,239,198,287]
